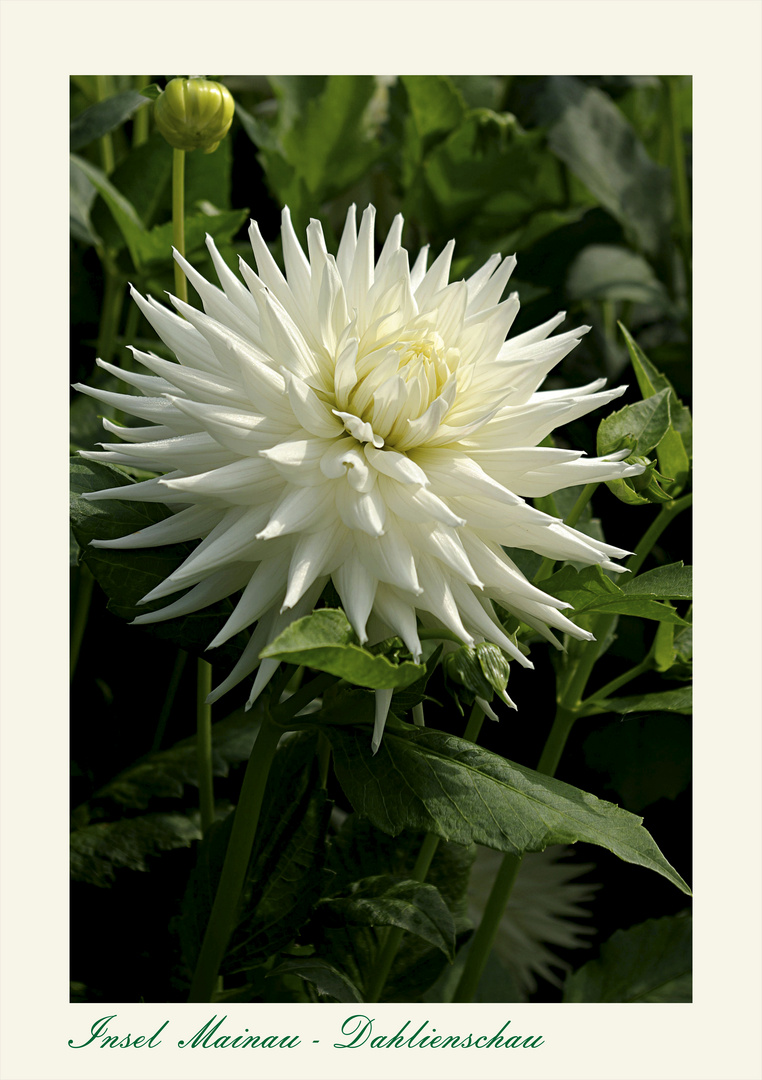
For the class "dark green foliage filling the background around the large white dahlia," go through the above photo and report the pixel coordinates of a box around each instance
[70,76,692,1005]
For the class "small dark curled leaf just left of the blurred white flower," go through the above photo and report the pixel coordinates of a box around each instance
[321,875,455,960]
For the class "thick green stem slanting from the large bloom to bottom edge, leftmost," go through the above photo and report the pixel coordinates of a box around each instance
[188,715,282,1002]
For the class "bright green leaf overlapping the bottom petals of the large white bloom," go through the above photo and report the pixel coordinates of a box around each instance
[260,608,426,690]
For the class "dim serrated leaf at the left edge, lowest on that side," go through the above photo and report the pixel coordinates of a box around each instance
[70,813,201,888]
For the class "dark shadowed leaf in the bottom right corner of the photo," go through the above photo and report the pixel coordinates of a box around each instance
[563,913,693,1003]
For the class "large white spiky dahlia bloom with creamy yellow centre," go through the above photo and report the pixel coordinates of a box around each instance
[79,206,640,742]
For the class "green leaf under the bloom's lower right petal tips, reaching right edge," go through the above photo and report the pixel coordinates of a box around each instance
[542,566,685,625]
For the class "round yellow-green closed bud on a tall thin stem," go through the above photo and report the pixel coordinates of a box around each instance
[153,79,235,153]
